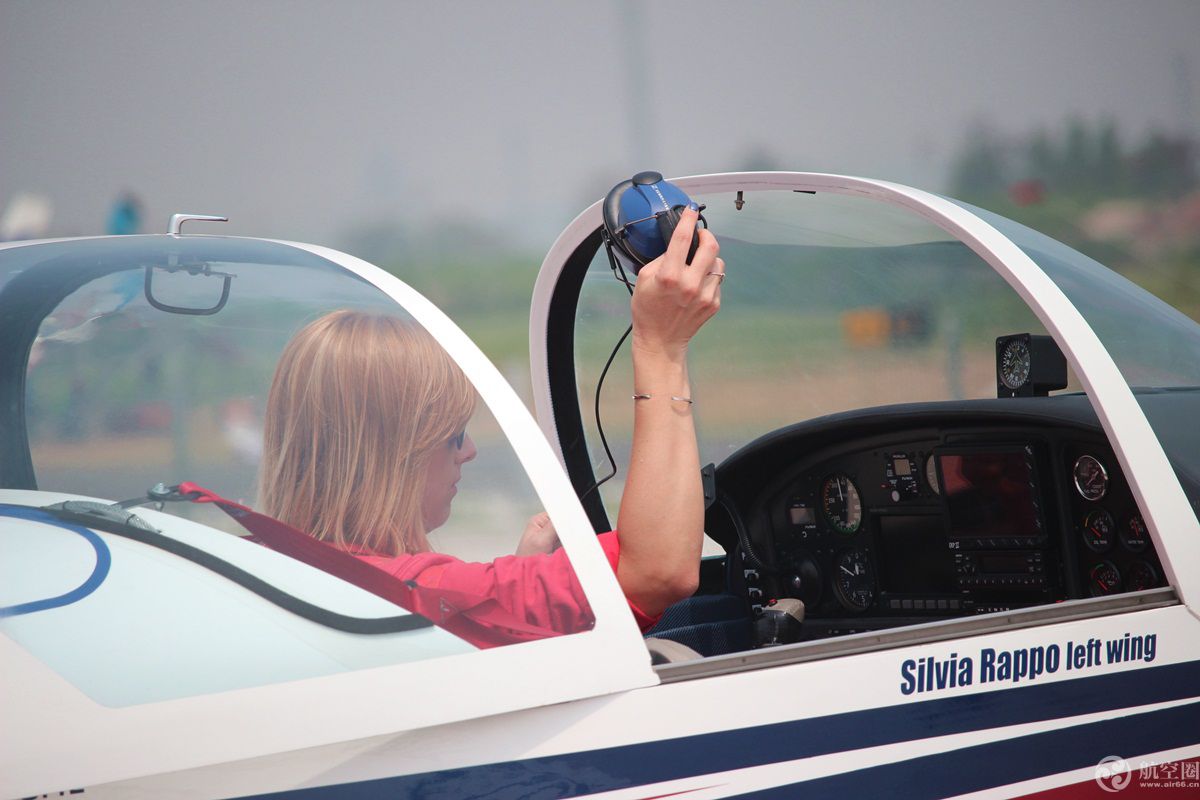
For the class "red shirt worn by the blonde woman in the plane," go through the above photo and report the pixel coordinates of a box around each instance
[356,531,658,648]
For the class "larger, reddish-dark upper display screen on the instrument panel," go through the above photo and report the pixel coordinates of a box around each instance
[937,451,1042,537]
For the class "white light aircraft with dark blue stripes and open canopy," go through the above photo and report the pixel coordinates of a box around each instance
[0,173,1200,799]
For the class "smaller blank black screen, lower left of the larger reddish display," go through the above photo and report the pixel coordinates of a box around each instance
[876,515,959,595]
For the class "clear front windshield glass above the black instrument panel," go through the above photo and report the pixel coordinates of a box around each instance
[575,191,1078,516]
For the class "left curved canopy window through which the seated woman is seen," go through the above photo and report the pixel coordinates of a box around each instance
[0,236,593,705]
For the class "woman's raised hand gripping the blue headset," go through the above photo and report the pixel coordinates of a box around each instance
[631,204,725,356]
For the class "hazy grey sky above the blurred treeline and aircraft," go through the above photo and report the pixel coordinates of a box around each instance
[0,0,1200,251]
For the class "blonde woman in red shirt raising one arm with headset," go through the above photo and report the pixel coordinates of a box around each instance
[259,209,725,646]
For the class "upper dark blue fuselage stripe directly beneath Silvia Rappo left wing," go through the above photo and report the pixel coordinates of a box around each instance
[238,661,1200,800]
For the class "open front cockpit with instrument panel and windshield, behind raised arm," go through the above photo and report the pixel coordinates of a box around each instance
[532,175,1200,655]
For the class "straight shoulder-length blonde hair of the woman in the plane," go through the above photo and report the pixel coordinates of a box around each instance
[259,311,475,555]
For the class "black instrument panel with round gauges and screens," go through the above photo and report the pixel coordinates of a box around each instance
[722,417,1164,638]
